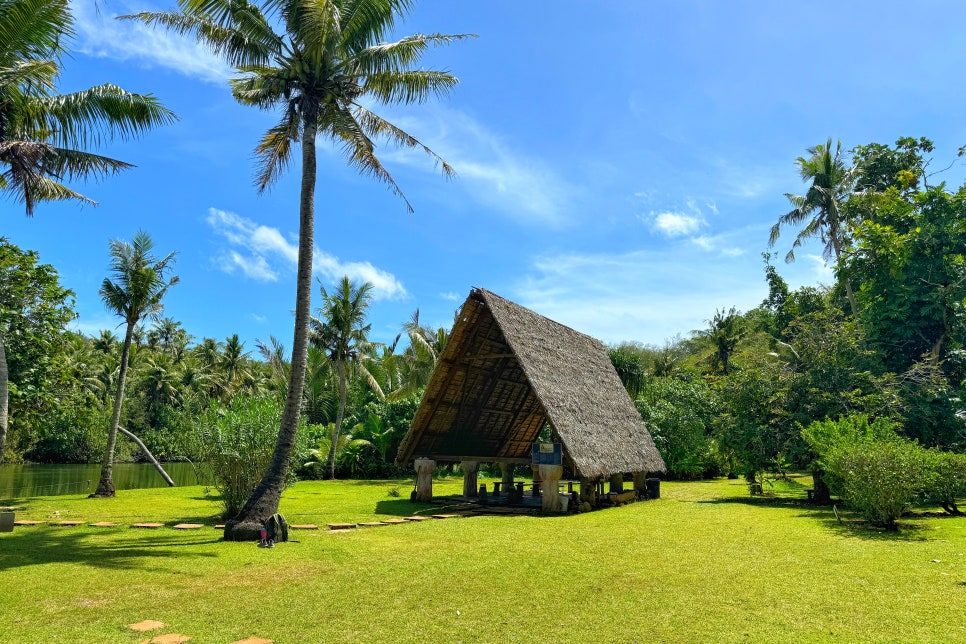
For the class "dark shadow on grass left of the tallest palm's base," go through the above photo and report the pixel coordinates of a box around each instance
[0,529,221,571]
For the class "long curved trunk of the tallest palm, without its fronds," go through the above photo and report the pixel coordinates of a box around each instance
[224,104,318,541]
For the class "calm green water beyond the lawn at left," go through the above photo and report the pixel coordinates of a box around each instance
[0,463,209,499]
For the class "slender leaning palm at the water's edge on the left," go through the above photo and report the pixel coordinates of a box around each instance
[94,231,178,497]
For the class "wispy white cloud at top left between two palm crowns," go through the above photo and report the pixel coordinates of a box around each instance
[71,0,231,85]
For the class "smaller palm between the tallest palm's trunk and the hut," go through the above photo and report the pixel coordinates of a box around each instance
[311,277,384,478]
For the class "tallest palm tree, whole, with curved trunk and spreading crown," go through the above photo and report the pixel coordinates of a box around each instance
[129,0,467,540]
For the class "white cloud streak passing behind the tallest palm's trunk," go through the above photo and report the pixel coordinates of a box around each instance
[205,208,408,299]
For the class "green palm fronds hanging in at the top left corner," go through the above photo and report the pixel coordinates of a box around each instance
[0,0,176,216]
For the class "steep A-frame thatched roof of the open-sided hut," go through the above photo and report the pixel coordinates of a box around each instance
[397,289,665,478]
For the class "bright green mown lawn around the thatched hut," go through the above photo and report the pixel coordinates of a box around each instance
[0,479,966,643]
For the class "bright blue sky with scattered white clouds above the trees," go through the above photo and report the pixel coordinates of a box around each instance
[0,0,966,350]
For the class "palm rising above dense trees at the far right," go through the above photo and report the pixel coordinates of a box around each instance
[768,139,859,315]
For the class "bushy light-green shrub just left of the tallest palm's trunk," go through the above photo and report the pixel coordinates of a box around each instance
[203,396,304,518]
